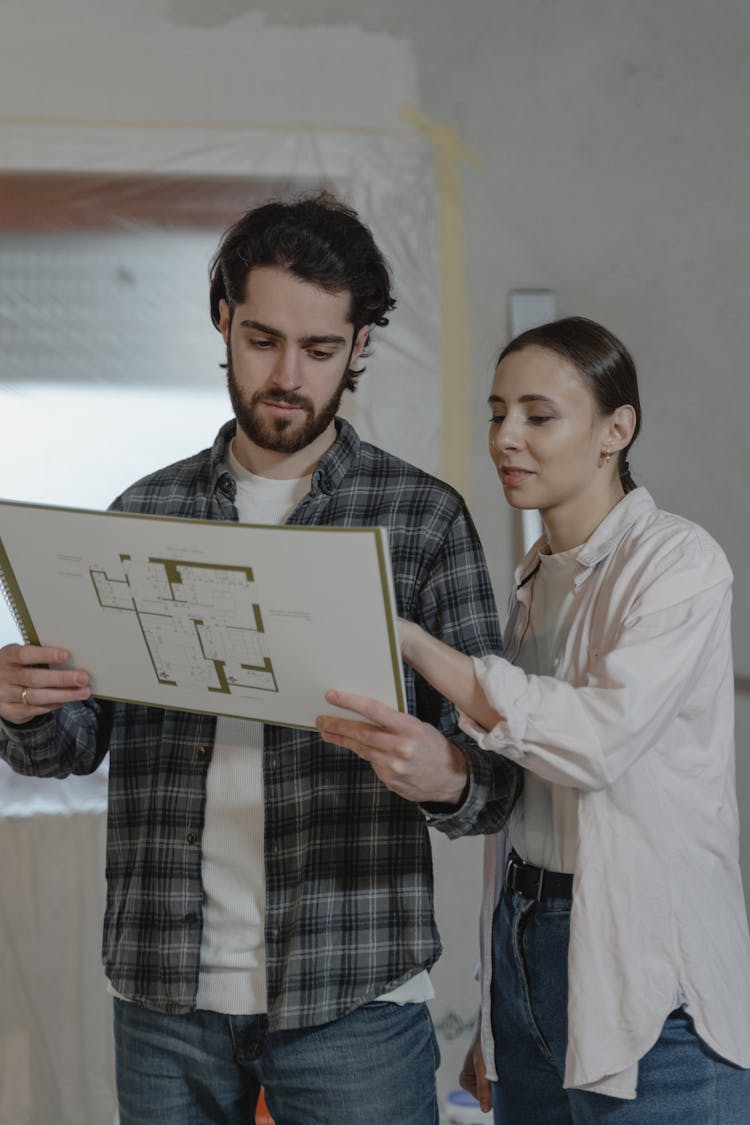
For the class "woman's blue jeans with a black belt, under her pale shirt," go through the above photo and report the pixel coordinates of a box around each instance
[493,888,750,1125]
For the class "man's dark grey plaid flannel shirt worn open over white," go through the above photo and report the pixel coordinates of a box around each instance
[0,420,519,1029]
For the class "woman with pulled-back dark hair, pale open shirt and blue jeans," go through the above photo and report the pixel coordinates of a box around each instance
[320,317,750,1125]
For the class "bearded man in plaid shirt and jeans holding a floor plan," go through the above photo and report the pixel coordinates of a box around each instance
[0,195,517,1125]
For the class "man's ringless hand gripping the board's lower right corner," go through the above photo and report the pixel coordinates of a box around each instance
[316,691,469,804]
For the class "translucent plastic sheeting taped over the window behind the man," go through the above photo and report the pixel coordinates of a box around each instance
[0,118,442,1125]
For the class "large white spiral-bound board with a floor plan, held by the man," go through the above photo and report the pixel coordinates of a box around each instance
[0,501,405,728]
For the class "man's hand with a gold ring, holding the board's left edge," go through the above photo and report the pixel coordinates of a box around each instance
[0,645,91,723]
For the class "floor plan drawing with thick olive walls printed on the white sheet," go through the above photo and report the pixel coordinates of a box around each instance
[89,555,278,694]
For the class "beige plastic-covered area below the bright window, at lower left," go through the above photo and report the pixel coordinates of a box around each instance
[0,813,115,1125]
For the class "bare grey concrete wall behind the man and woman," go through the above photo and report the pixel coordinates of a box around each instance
[0,0,750,1111]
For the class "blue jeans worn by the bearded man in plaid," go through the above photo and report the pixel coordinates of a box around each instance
[115,1000,440,1125]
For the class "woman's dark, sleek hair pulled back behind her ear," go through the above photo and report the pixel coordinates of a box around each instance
[496,316,641,493]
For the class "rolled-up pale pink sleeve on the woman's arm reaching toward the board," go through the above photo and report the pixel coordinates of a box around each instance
[460,537,732,790]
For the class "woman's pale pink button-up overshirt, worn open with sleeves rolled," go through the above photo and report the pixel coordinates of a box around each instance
[462,488,750,1098]
